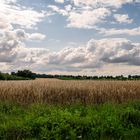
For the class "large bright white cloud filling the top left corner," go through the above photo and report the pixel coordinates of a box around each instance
[0,0,47,29]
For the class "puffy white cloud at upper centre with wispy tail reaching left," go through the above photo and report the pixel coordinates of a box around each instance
[48,5,111,28]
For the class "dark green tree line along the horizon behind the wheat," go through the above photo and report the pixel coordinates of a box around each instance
[0,70,140,80]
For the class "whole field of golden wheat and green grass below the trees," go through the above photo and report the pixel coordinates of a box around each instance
[0,79,140,140]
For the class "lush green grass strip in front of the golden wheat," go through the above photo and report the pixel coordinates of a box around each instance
[0,102,140,140]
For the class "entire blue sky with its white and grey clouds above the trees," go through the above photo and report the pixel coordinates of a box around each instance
[0,0,140,75]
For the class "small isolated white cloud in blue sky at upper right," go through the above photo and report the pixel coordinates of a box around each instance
[114,14,133,23]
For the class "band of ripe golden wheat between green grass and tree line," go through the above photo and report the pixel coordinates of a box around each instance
[0,79,140,104]
